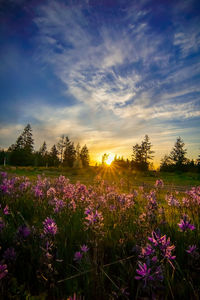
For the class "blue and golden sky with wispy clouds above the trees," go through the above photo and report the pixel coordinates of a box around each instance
[0,0,200,164]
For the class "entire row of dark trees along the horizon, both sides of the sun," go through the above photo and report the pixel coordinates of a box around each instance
[0,124,200,172]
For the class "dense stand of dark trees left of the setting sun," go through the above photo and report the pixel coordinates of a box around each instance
[0,124,90,168]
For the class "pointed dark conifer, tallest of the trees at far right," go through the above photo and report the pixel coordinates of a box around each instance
[170,136,187,169]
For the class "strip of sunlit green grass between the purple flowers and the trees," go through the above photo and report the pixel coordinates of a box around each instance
[0,166,200,189]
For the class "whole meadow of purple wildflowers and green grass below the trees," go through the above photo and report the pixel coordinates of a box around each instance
[0,167,200,300]
